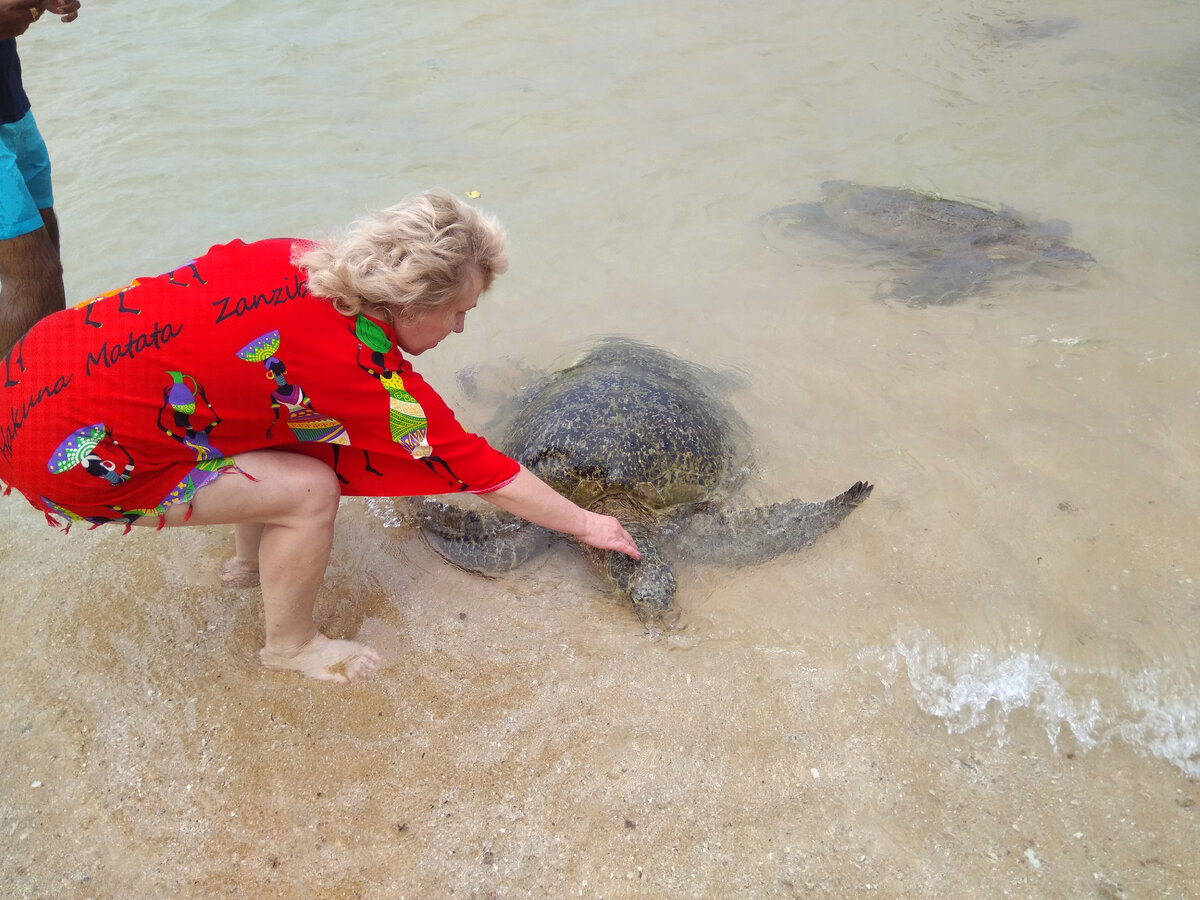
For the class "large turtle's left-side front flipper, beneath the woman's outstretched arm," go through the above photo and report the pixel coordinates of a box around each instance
[416,499,552,574]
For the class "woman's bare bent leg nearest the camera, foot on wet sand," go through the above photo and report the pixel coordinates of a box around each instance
[147,450,379,682]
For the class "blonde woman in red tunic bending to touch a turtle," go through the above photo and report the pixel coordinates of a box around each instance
[0,192,640,682]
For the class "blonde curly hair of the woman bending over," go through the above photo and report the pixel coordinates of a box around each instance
[300,191,509,318]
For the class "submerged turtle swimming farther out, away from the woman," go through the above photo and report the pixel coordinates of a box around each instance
[762,181,1094,306]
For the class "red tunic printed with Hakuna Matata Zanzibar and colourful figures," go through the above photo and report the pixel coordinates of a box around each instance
[0,239,517,523]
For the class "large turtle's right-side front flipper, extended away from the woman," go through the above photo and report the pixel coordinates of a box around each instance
[678,481,875,565]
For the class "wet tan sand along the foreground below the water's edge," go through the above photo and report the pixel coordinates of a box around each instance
[0,502,1200,898]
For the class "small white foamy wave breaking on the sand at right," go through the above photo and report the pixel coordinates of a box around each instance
[859,631,1200,778]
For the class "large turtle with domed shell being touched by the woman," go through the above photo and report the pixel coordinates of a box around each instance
[418,338,872,625]
